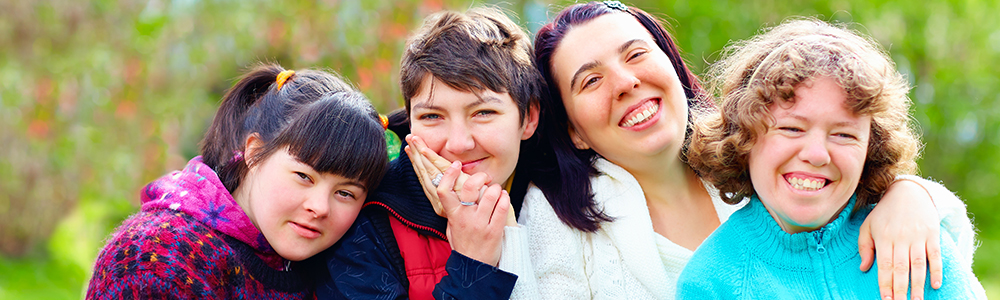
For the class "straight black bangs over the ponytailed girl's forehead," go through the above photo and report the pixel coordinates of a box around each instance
[274,91,388,191]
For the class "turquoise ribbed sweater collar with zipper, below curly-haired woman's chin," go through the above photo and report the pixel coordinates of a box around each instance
[736,195,867,267]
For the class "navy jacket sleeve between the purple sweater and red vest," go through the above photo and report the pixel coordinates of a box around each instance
[316,213,407,299]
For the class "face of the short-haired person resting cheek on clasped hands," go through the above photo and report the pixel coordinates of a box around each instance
[410,75,538,184]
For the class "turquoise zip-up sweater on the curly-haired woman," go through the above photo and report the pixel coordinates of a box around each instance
[677,196,986,299]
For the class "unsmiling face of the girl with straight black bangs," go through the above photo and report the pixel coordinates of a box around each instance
[234,148,367,261]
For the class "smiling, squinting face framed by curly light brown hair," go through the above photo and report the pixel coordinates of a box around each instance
[749,77,871,233]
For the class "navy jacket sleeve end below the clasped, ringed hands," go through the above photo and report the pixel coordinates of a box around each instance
[433,250,517,299]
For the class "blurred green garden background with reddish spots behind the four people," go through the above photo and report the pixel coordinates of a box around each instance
[0,0,1000,299]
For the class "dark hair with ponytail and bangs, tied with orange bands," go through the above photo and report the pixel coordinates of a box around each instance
[202,64,387,193]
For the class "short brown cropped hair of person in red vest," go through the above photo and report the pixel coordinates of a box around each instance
[399,7,544,122]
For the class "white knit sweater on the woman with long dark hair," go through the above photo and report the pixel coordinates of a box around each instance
[500,159,975,299]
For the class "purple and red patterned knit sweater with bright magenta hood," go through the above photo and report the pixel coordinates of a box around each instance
[87,156,315,299]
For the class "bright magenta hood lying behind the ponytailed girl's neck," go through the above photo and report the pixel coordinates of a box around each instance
[142,156,274,253]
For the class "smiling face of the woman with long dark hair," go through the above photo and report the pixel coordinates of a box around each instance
[552,13,688,169]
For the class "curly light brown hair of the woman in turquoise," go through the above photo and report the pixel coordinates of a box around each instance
[688,18,921,207]
